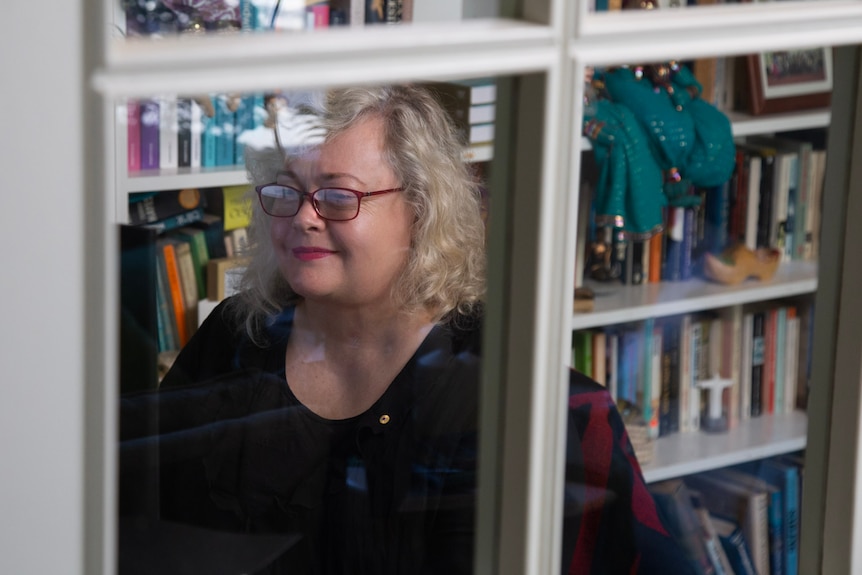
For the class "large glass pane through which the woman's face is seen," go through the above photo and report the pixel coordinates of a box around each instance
[117,78,505,574]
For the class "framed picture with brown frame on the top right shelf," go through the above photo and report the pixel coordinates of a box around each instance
[747,48,832,115]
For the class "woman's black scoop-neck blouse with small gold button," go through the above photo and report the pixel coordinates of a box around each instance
[124,303,480,575]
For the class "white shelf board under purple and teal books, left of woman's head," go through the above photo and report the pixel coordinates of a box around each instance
[125,166,249,194]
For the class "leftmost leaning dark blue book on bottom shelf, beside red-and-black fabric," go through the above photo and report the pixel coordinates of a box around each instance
[649,479,716,575]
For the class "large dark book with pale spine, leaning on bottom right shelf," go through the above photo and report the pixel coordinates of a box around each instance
[685,472,771,574]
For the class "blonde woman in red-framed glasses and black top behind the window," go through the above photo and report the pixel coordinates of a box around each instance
[125,86,686,575]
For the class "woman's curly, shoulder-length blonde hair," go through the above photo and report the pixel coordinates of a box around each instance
[231,85,485,344]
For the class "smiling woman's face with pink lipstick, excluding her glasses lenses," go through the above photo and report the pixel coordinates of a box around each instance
[270,117,413,312]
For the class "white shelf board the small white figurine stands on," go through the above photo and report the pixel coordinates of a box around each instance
[642,411,808,483]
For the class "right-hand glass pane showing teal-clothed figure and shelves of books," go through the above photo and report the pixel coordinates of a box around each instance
[563,48,831,573]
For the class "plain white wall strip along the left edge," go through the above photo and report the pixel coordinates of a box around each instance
[0,4,84,575]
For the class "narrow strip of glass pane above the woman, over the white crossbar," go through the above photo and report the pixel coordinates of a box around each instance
[116,0,500,37]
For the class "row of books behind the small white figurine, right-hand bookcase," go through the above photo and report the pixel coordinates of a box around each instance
[572,298,813,437]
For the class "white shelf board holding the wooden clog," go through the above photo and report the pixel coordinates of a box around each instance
[572,262,817,330]
